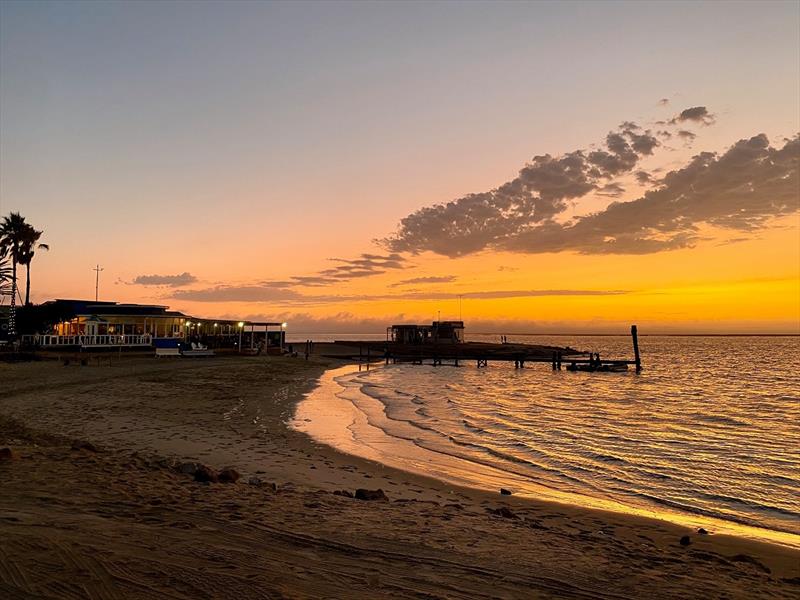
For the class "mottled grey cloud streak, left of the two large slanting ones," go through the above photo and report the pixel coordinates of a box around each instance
[378,122,659,256]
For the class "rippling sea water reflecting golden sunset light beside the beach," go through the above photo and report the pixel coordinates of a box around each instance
[294,336,800,546]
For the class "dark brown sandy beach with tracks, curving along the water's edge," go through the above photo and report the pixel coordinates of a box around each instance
[0,357,800,600]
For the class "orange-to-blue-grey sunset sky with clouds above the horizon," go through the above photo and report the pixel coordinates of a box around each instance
[0,1,800,333]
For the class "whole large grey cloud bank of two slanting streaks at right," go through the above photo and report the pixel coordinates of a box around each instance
[381,132,800,257]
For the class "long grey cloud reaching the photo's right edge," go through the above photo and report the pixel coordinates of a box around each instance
[504,134,800,254]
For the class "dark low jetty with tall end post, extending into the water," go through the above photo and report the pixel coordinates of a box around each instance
[323,325,642,373]
